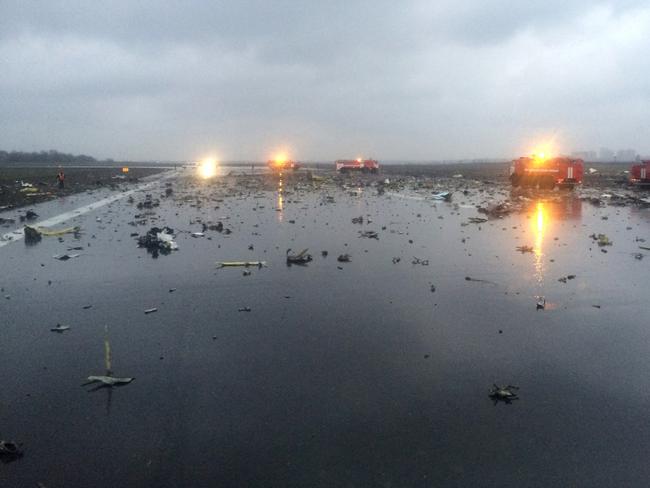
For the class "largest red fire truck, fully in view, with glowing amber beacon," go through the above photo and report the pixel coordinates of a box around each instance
[510,155,584,189]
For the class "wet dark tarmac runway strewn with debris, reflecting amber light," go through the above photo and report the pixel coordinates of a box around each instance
[0,169,650,488]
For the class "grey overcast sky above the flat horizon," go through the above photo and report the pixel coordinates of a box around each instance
[0,0,650,161]
